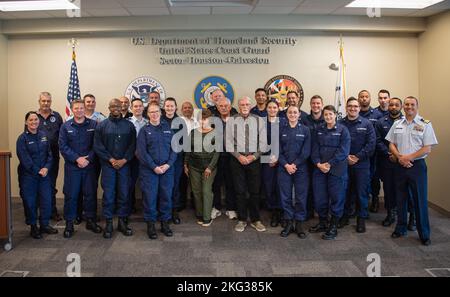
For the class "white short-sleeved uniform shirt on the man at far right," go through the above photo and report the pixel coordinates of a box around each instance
[386,115,438,160]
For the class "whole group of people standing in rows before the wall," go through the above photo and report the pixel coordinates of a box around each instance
[17,88,437,245]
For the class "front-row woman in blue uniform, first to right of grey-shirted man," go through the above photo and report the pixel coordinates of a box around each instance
[278,105,311,239]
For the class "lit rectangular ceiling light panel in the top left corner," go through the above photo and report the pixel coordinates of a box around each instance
[0,0,80,11]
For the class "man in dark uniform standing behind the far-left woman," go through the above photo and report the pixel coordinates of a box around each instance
[37,92,63,221]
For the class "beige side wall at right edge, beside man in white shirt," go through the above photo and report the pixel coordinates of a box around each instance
[419,12,450,213]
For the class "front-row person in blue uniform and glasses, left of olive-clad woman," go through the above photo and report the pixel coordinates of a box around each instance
[136,103,177,239]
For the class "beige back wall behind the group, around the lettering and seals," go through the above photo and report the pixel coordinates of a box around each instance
[8,32,419,195]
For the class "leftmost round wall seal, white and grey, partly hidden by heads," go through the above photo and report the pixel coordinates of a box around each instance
[124,76,166,107]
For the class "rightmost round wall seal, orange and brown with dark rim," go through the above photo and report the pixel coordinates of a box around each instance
[264,75,304,108]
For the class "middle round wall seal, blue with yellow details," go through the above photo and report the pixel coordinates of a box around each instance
[194,76,234,109]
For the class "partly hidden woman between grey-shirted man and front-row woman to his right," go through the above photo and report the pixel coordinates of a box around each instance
[262,99,281,227]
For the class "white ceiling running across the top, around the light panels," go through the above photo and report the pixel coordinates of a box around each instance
[0,0,450,20]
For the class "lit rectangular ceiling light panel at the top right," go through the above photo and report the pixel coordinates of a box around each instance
[345,0,444,9]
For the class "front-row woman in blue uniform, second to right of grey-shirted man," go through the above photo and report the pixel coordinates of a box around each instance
[310,105,350,240]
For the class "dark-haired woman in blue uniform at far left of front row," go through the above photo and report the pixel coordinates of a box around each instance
[16,111,58,239]
